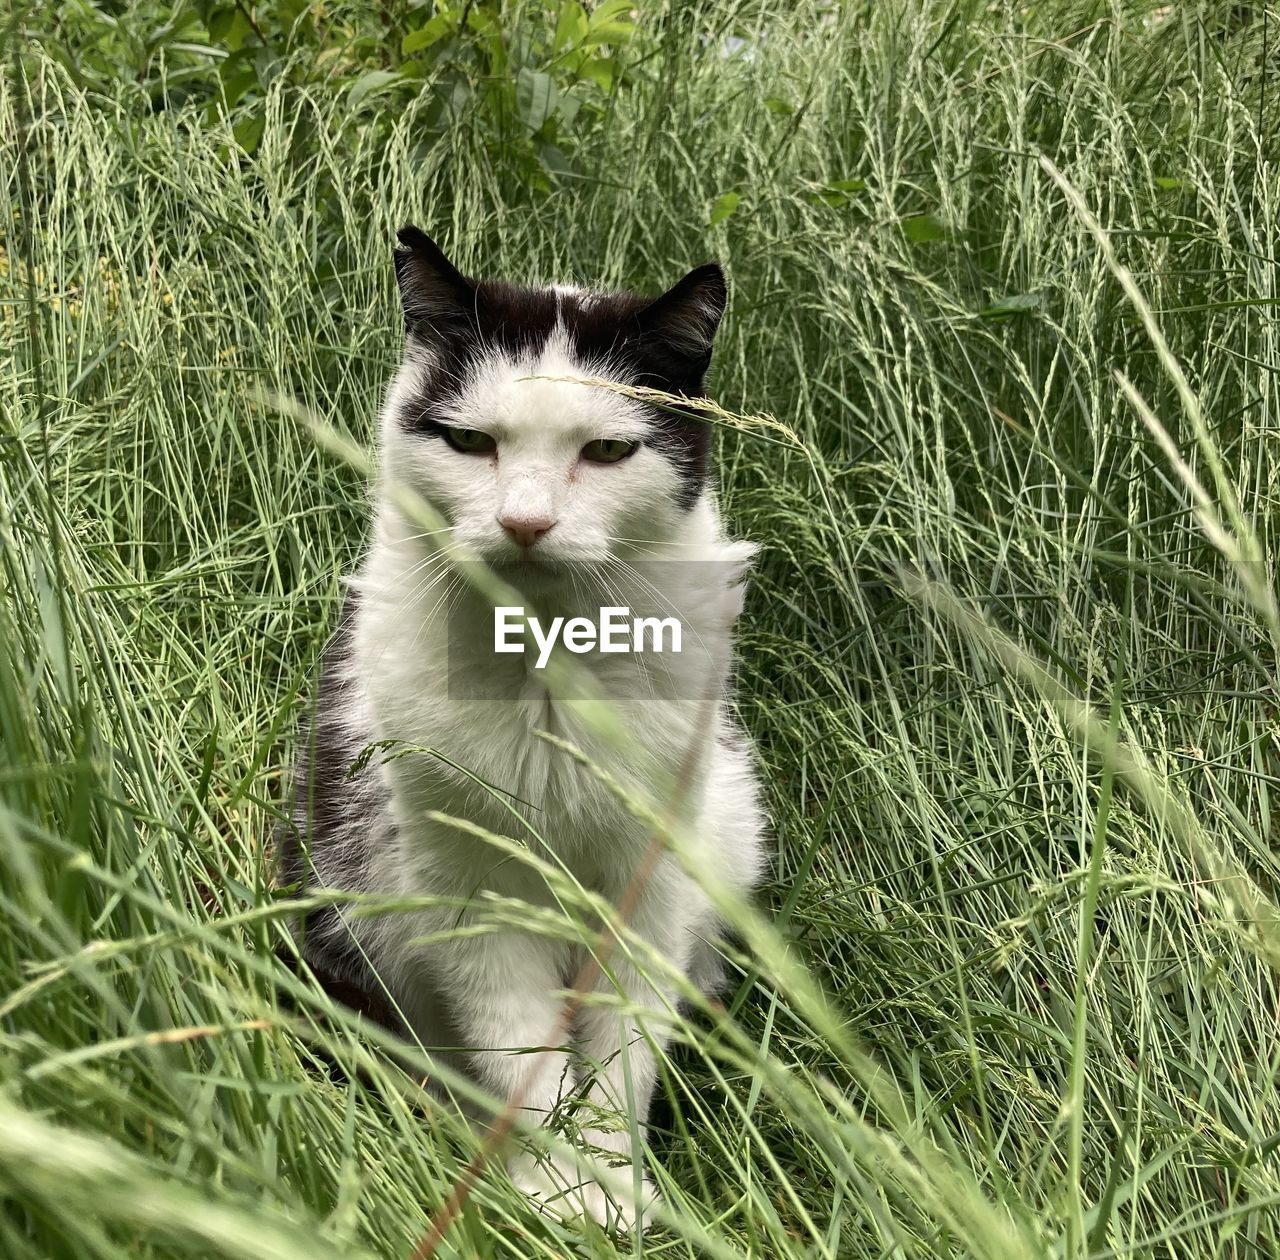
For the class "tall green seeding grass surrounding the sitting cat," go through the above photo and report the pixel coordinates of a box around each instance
[0,0,1280,1260]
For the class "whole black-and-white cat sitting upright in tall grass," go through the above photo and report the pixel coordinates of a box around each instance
[283,227,765,1228]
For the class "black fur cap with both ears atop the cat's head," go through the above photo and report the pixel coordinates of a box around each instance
[396,227,726,508]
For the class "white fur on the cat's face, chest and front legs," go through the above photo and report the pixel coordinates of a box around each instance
[318,315,764,1223]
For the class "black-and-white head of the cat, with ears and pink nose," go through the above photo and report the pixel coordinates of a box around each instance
[383,228,724,562]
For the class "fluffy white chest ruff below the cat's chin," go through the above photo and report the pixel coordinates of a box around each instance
[351,514,749,857]
